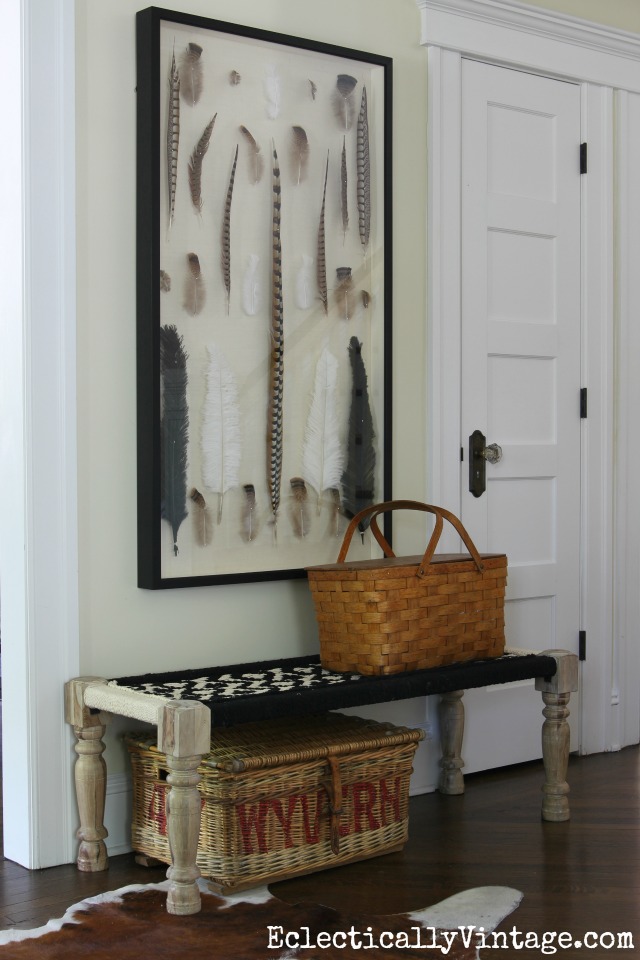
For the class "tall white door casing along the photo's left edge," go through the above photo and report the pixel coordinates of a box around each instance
[0,0,80,868]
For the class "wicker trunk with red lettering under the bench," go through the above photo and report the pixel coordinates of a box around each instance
[125,713,423,893]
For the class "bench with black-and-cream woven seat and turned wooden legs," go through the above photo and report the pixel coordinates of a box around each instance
[65,650,578,914]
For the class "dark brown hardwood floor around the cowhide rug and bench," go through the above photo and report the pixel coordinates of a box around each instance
[0,747,640,960]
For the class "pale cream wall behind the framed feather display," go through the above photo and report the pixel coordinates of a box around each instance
[76,0,426,788]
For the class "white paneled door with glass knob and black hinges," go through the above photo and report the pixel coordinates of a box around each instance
[461,60,581,770]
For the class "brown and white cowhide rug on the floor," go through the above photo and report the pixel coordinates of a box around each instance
[0,880,522,960]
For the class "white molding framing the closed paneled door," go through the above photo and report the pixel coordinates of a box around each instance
[417,0,640,753]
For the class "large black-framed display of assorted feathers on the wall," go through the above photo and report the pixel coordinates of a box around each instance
[137,7,392,589]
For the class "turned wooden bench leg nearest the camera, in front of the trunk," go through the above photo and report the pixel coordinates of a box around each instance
[158,700,211,915]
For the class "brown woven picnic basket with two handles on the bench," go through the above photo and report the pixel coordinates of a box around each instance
[307,500,507,675]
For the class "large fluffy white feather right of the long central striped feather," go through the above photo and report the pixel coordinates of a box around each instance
[302,347,344,509]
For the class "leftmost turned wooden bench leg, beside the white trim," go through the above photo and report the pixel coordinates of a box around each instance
[65,677,109,873]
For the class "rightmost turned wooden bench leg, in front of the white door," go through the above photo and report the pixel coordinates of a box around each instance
[536,650,578,823]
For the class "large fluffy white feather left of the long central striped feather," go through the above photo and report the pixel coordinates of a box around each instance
[200,344,242,523]
